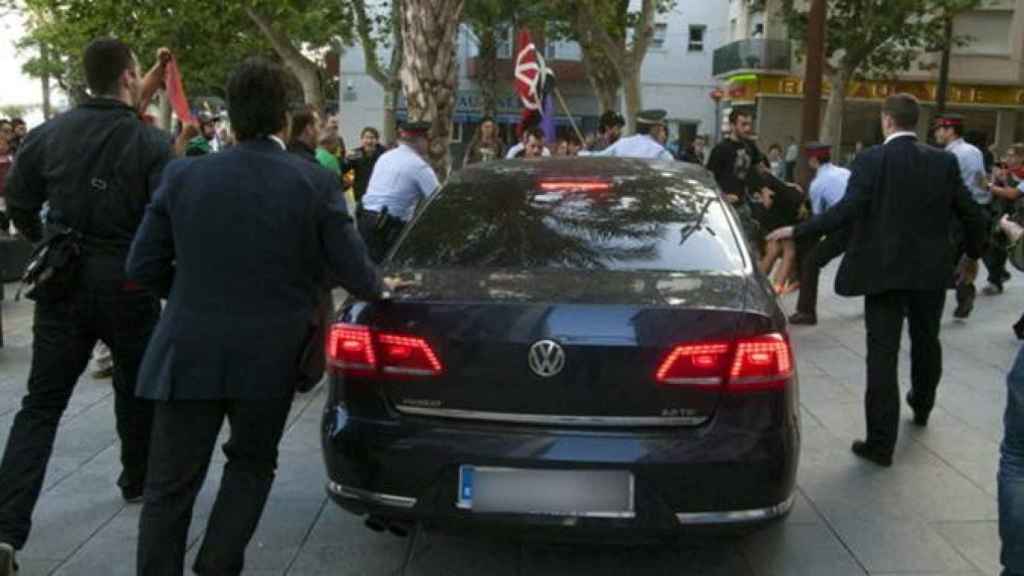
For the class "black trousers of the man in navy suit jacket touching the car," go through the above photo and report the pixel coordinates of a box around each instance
[137,397,292,576]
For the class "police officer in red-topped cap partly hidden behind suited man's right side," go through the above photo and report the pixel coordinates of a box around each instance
[935,114,1002,319]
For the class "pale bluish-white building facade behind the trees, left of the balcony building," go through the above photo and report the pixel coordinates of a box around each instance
[339,0,728,161]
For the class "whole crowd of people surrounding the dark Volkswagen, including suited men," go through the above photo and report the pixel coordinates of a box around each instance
[0,39,1024,576]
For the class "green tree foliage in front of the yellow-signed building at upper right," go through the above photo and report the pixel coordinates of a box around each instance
[782,0,983,77]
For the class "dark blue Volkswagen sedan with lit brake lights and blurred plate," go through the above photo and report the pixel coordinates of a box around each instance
[322,158,800,533]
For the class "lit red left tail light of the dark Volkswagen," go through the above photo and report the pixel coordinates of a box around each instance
[327,324,443,376]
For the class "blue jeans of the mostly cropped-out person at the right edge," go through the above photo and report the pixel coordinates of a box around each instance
[999,347,1024,576]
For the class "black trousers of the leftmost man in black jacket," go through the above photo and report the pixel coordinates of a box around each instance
[0,258,160,548]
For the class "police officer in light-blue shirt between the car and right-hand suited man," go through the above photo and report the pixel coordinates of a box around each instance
[790,142,850,325]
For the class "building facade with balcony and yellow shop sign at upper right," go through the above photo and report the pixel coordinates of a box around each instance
[714,0,1024,156]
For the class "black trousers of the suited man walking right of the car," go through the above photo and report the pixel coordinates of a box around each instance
[864,290,946,453]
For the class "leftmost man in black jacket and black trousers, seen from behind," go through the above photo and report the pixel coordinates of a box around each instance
[0,39,172,576]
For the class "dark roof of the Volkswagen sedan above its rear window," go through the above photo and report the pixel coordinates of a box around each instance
[449,157,715,189]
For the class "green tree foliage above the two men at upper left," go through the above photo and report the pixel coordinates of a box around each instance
[8,0,351,101]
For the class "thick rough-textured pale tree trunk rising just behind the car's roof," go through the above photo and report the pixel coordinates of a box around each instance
[400,0,465,179]
